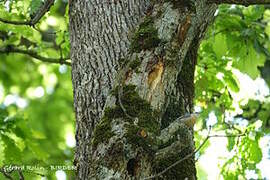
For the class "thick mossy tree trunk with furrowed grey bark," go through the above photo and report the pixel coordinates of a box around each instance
[70,0,217,179]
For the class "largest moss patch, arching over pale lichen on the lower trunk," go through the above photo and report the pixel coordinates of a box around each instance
[93,85,160,151]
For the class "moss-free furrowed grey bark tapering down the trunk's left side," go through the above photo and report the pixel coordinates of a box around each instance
[70,0,148,179]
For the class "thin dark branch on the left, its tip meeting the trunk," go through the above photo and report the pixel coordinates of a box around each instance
[0,45,71,66]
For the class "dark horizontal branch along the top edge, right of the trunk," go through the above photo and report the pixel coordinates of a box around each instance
[208,0,270,6]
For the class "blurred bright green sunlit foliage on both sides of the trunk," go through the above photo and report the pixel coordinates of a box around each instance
[0,0,270,180]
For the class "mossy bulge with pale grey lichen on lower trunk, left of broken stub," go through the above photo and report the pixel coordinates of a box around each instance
[90,85,162,178]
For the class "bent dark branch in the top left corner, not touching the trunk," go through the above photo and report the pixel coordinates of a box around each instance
[0,0,54,26]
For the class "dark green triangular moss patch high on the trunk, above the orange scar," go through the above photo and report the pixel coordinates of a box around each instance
[131,16,160,52]
